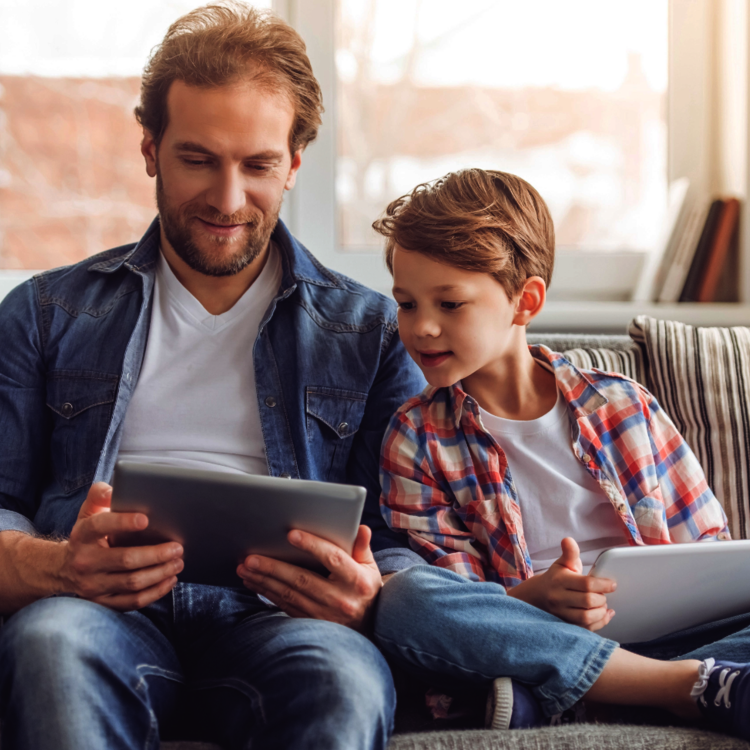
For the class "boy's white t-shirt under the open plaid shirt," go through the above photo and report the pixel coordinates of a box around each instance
[479,390,626,574]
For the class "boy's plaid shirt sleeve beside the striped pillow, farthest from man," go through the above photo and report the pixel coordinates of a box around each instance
[638,389,730,544]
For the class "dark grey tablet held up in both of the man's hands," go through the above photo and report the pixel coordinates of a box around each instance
[112,461,366,586]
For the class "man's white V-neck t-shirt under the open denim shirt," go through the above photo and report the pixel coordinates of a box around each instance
[118,245,281,474]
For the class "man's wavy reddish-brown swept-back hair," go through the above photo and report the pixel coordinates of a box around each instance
[135,0,323,154]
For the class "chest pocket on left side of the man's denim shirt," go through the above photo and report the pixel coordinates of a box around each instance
[47,370,119,494]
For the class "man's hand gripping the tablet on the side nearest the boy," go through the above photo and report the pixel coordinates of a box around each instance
[237,526,382,630]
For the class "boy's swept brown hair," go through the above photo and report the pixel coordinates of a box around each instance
[372,169,555,298]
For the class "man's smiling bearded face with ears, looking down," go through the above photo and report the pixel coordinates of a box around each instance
[141,81,300,276]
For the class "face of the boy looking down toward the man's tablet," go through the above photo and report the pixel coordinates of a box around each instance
[393,245,525,387]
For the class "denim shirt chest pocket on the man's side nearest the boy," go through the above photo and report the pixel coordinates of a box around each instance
[305,385,367,482]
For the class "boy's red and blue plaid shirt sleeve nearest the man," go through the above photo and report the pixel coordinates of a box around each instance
[380,407,494,581]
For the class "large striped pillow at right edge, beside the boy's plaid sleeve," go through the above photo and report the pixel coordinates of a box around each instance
[629,315,750,539]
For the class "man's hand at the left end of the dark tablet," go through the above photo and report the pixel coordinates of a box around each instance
[57,482,183,611]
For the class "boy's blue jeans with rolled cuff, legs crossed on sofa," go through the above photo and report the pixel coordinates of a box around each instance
[375,565,750,716]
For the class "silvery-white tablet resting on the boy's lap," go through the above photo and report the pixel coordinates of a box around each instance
[589,540,750,643]
